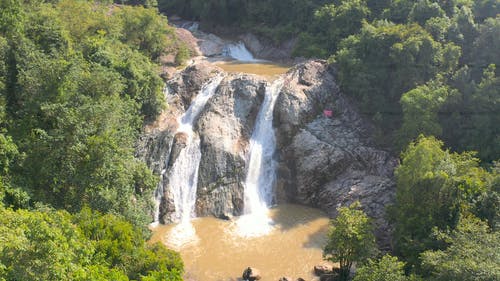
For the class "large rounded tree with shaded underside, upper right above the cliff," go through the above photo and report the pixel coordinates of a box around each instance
[333,22,458,136]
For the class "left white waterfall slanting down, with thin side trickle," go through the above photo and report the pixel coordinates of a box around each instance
[152,76,224,226]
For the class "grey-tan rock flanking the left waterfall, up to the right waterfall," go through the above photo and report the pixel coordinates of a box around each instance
[137,60,266,223]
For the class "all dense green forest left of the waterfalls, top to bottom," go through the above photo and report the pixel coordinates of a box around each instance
[0,0,188,280]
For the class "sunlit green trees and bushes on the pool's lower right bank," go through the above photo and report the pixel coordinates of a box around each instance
[324,136,500,281]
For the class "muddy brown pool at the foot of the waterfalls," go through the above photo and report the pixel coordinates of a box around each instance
[151,204,329,281]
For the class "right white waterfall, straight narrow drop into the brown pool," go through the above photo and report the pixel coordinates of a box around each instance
[237,79,283,236]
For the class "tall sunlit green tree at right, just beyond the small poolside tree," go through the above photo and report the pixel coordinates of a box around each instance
[389,136,494,269]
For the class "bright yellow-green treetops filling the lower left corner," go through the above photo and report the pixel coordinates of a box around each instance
[0,207,183,281]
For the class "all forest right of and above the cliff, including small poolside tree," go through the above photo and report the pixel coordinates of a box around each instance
[158,0,500,281]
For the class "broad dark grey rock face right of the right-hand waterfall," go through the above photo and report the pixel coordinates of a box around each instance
[274,61,397,247]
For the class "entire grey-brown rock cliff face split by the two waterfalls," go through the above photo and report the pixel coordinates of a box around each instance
[138,61,397,245]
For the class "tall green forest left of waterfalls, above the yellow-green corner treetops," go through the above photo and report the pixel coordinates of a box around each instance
[0,0,188,226]
